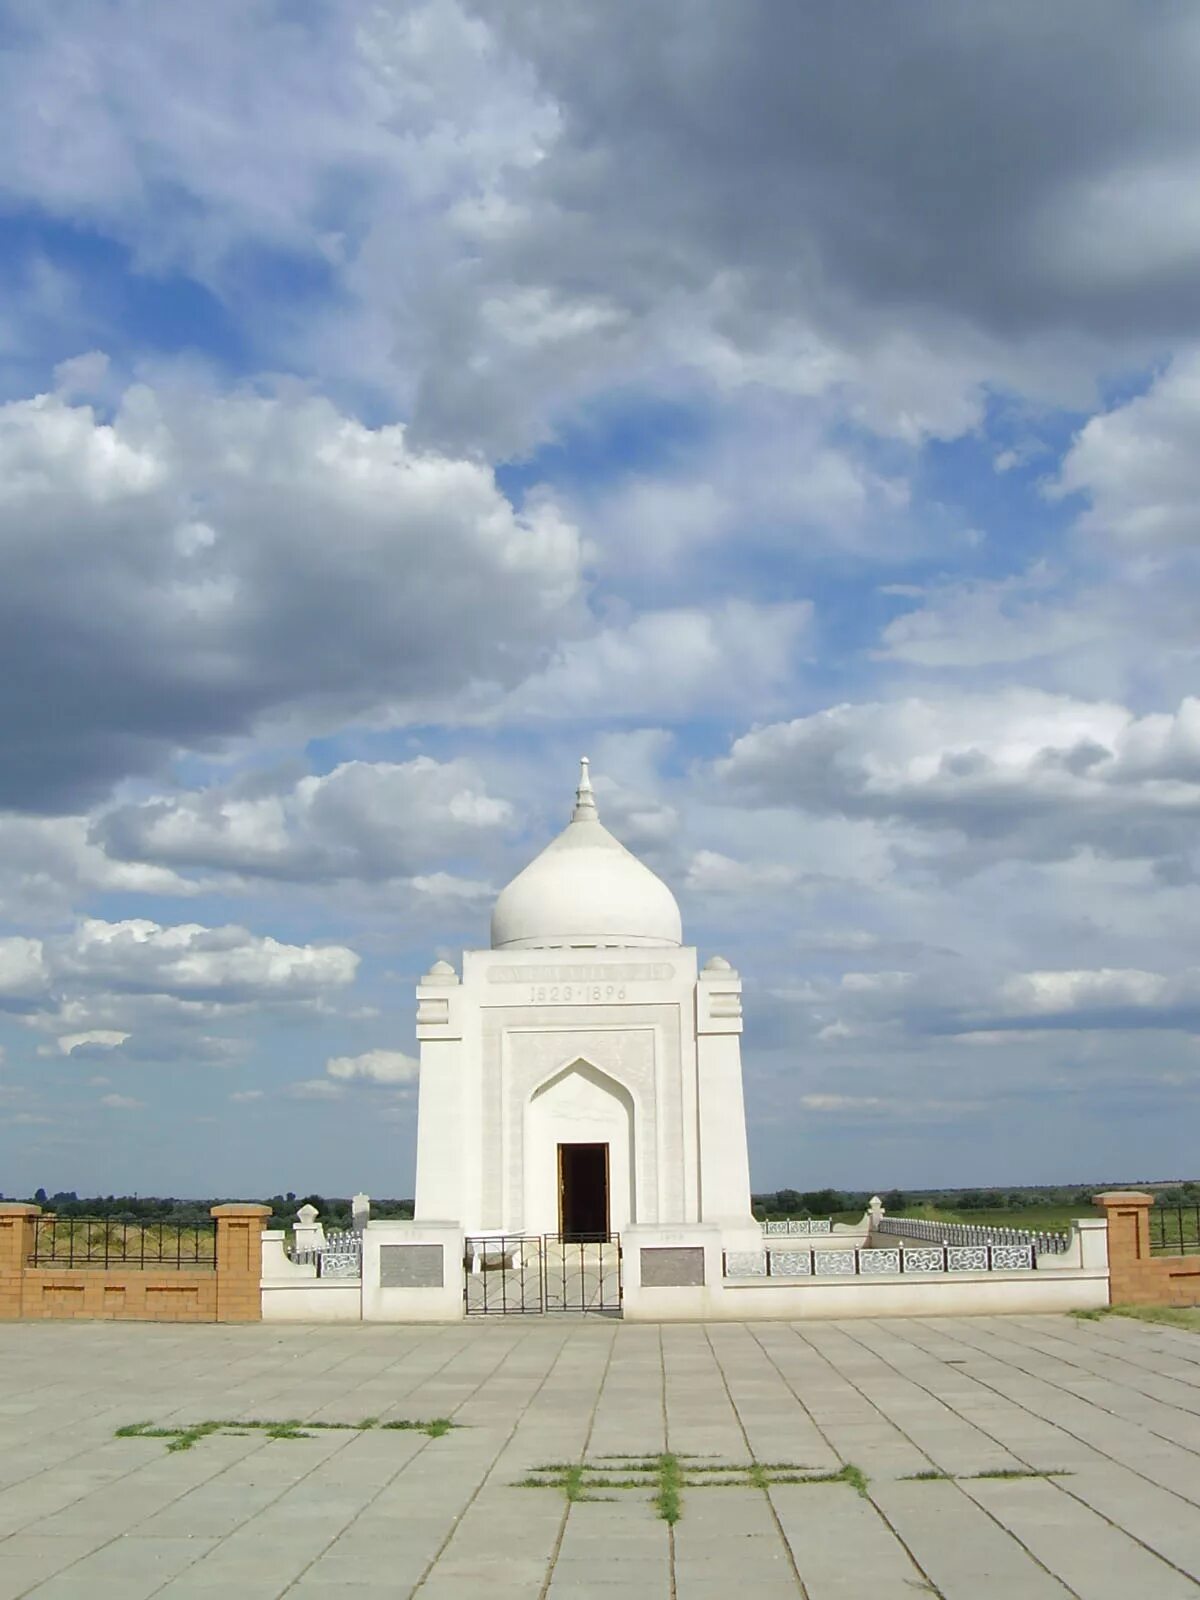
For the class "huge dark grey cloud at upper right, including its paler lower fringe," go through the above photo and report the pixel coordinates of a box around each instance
[406,0,1200,448]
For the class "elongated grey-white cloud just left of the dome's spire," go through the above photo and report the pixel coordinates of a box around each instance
[93,755,514,894]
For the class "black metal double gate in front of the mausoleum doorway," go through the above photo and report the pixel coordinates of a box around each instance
[462,1234,621,1317]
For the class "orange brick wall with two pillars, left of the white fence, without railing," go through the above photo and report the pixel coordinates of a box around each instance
[0,1205,270,1322]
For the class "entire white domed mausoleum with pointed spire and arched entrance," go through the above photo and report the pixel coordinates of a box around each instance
[416,758,762,1248]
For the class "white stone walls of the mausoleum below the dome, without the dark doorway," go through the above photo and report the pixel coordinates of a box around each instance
[416,946,757,1234]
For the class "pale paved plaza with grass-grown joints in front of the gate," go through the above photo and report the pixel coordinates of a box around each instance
[0,1317,1200,1600]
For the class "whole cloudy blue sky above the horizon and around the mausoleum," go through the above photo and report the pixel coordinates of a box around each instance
[0,0,1200,1197]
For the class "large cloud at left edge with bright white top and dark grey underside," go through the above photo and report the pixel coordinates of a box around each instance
[0,374,579,810]
